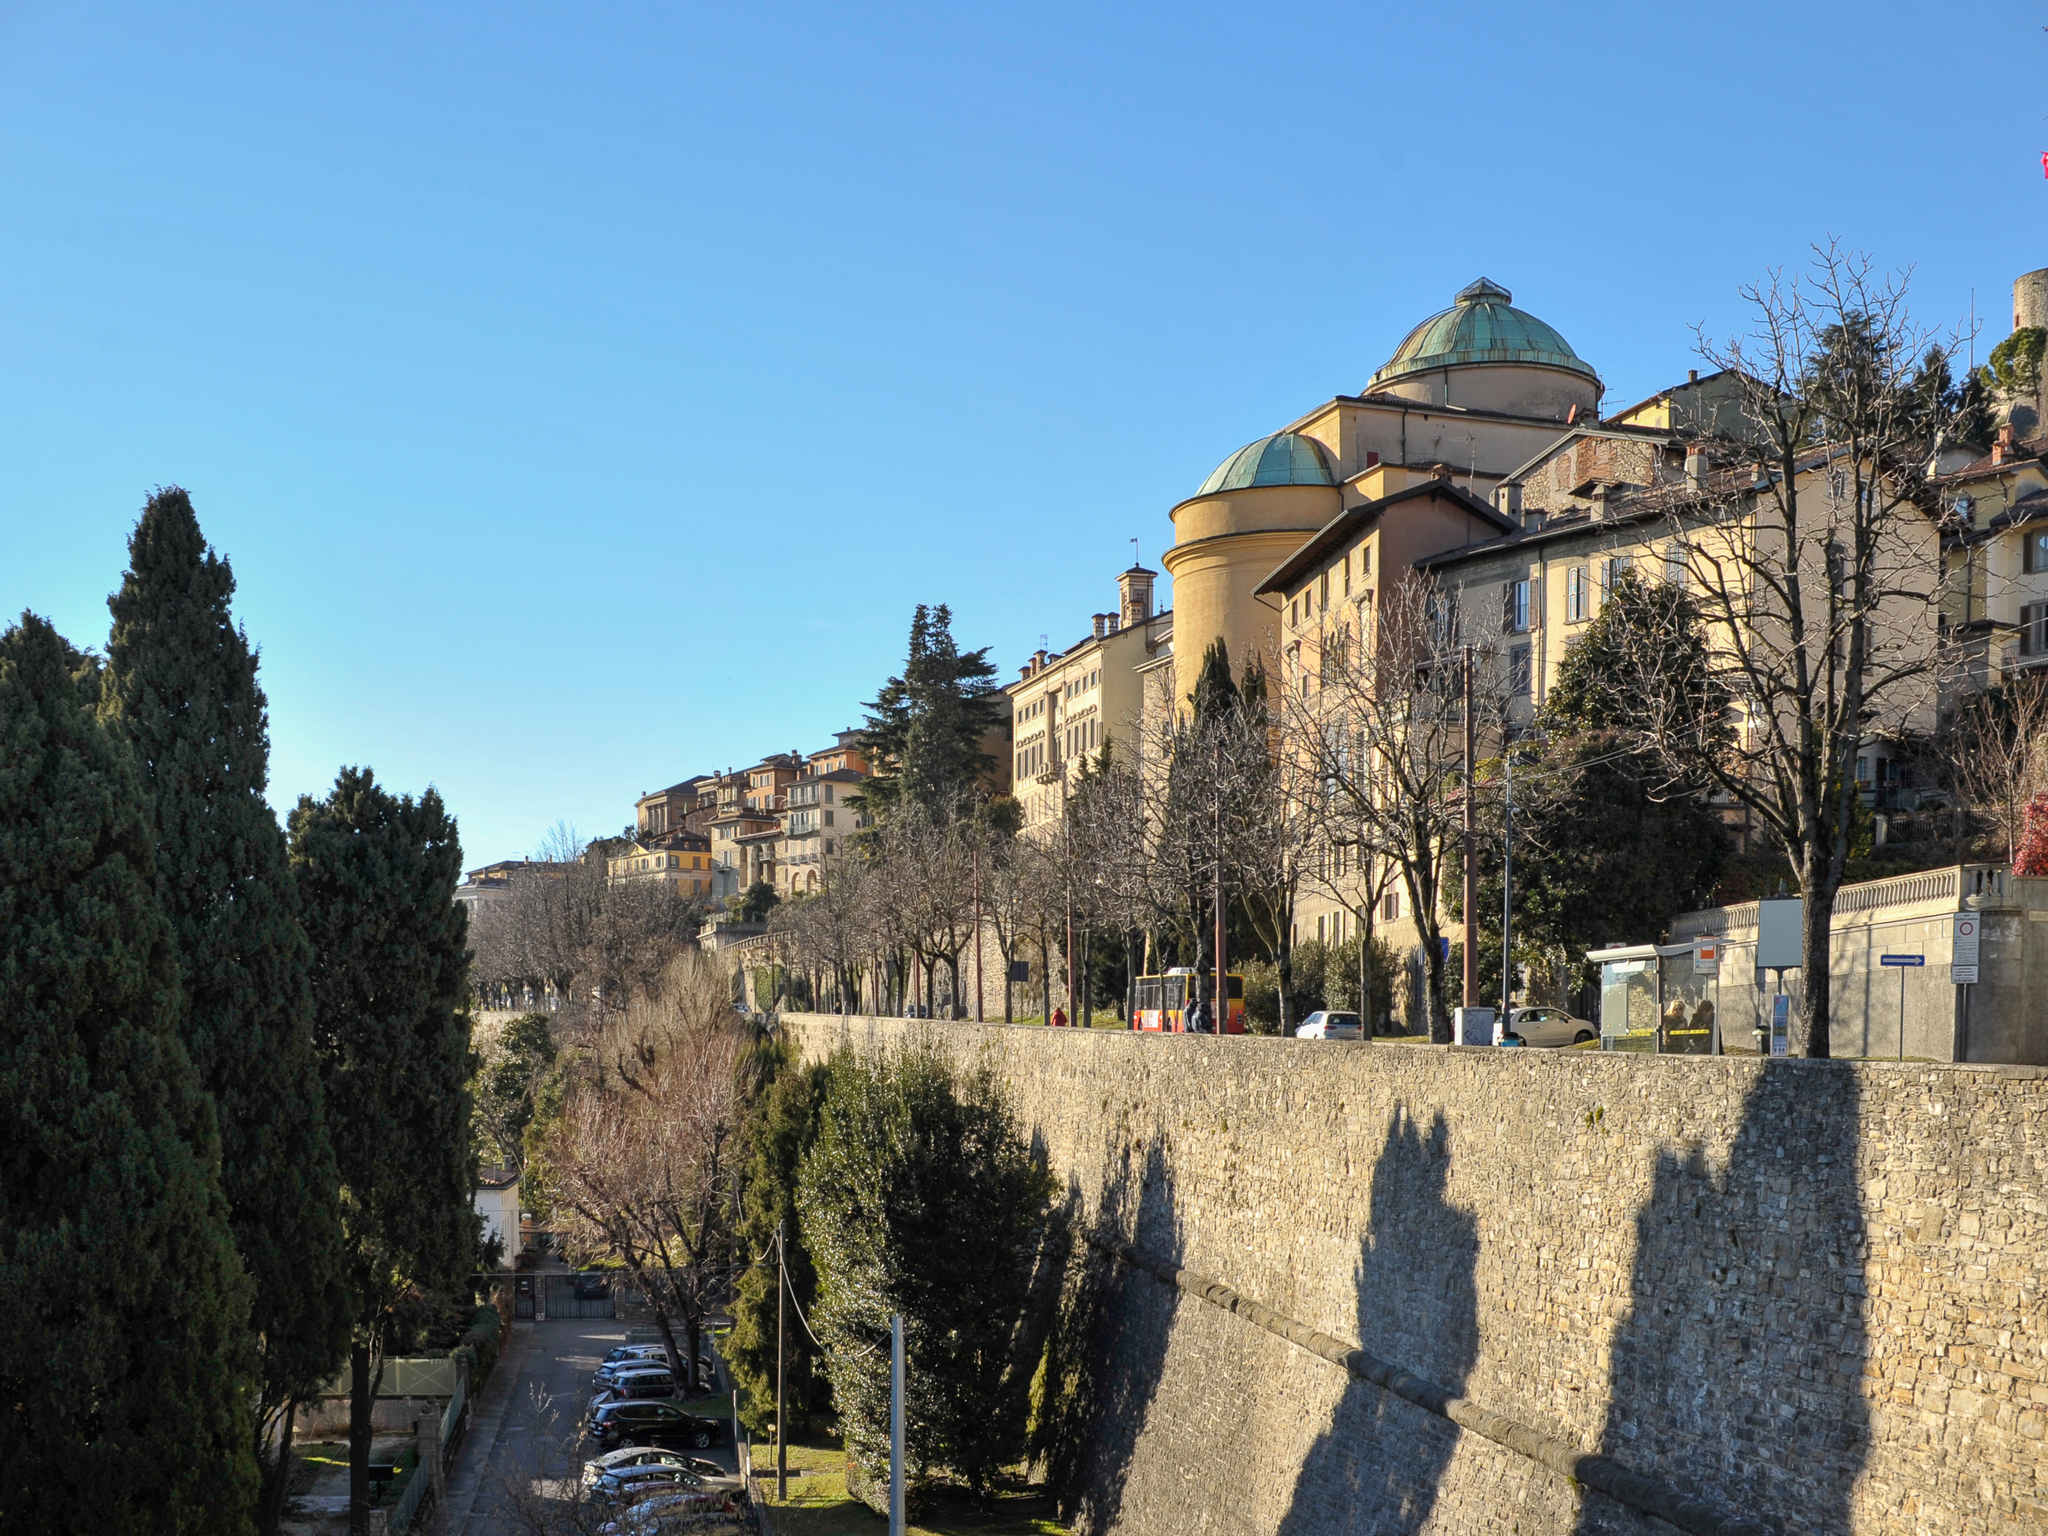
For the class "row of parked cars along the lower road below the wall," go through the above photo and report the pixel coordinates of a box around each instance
[584,1343,748,1536]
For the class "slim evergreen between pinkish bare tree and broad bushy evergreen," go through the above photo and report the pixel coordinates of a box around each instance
[725,1040,831,1436]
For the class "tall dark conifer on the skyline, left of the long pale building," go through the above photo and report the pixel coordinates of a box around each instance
[850,602,1004,823]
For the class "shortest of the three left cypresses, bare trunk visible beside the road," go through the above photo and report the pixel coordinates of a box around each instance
[291,768,477,1536]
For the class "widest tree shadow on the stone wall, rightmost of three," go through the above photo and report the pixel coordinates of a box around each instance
[1579,1061,1870,1536]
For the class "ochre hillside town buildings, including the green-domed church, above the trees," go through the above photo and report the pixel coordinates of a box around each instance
[475,268,2048,1048]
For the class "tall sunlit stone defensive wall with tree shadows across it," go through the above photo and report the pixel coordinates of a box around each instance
[784,1014,2048,1536]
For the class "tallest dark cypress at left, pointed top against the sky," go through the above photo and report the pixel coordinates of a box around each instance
[100,487,348,1530]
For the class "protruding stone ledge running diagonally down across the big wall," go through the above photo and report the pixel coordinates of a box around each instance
[1087,1235,1774,1536]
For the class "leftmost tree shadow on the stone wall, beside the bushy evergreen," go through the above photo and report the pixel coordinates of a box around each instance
[1032,1147,1182,1530]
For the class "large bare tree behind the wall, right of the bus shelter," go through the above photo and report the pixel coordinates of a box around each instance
[1638,244,1952,1057]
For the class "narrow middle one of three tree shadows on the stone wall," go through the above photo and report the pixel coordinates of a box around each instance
[1280,1108,1479,1536]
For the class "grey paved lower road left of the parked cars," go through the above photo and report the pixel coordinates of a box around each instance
[444,1317,733,1536]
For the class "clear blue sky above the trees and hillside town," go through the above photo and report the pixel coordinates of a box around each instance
[0,0,2048,864]
